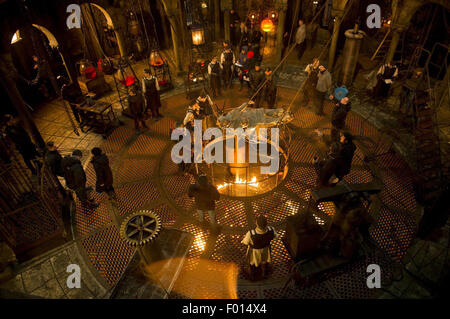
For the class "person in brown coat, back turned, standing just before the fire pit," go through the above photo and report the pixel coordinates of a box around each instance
[188,175,220,225]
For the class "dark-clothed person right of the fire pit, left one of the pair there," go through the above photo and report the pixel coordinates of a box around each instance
[313,143,342,187]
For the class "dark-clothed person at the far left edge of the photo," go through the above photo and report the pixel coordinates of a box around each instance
[4,114,42,175]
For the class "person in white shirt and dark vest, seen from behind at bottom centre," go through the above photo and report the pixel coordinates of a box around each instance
[241,215,278,280]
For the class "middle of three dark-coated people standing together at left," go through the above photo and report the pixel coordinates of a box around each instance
[61,150,99,208]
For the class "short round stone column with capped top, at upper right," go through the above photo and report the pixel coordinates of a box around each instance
[339,27,365,87]
